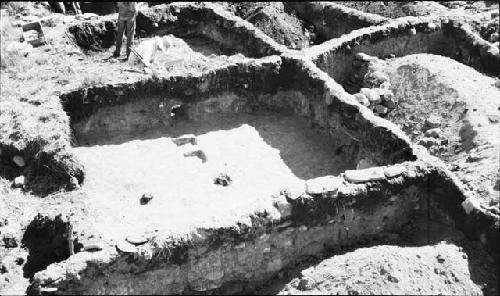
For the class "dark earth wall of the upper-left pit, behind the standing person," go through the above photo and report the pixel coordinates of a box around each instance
[68,3,286,57]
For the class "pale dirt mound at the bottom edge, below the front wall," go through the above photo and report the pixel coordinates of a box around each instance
[279,244,482,295]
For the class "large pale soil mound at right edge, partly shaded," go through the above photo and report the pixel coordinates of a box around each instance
[366,54,500,210]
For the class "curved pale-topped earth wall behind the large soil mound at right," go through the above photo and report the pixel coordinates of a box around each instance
[305,17,500,82]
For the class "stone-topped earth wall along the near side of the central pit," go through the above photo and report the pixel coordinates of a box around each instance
[34,163,425,294]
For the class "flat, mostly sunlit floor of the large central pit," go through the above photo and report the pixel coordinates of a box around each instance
[75,114,345,243]
